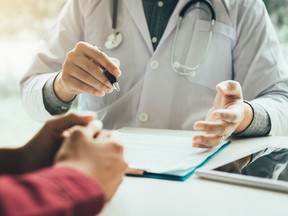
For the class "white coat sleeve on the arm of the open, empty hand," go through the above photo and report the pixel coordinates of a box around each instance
[230,0,288,135]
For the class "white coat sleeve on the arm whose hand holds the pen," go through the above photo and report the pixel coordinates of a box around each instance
[20,0,90,121]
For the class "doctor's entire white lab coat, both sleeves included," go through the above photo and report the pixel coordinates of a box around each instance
[21,0,288,134]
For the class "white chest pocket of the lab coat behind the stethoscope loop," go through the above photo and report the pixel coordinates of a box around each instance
[185,20,236,89]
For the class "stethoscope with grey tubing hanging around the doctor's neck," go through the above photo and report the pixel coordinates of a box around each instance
[105,0,216,76]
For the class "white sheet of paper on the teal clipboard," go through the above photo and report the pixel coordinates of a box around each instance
[119,132,226,175]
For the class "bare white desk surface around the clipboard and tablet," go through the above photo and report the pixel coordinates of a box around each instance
[100,130,288,216]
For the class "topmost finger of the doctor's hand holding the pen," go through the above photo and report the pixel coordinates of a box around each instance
[77,42,121,77]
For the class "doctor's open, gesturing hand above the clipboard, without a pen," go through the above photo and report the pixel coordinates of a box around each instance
[192,80,253,148]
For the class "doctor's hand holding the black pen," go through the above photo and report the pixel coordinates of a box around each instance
[54,42,121,102]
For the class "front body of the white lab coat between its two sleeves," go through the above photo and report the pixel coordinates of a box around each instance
[51,0,272,130]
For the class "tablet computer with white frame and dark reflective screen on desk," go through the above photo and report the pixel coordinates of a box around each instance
[196,147,288,193]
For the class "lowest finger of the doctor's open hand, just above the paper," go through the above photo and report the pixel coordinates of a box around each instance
[192,134,225,148]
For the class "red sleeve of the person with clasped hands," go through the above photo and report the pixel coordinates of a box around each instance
[0,167,104,216]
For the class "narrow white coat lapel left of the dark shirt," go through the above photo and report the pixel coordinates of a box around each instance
[123,0,153,53]
